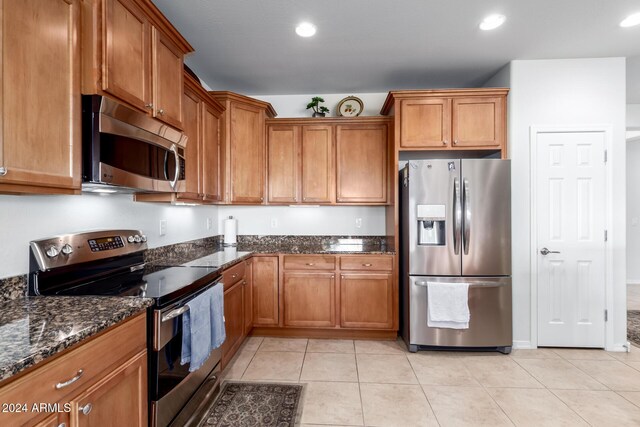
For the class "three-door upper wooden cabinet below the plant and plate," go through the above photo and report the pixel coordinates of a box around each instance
[267,117,392,205]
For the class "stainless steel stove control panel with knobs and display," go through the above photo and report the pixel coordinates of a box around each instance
[29,230,147,271]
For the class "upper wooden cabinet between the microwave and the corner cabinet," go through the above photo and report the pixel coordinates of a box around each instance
[135,72,224,204]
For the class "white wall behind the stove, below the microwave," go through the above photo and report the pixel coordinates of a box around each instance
[0,195,218,278]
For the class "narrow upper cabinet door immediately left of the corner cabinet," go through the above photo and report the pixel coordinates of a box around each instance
[202,102,222,201]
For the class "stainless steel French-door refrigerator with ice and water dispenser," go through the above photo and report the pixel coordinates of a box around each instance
[400,159,512,353]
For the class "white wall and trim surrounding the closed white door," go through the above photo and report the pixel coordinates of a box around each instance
[488,58,626,349]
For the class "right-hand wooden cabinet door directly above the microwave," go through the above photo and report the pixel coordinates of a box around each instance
[152,27,184,129]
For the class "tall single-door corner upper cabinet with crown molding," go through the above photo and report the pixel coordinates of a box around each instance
[209,91,276,205]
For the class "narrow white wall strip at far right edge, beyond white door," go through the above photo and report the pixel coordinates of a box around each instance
[627,138,640,284]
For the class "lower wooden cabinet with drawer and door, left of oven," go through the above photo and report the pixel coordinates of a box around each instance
[0,314,148,427]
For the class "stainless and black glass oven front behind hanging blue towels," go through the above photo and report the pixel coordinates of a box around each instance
[149,278,223,426]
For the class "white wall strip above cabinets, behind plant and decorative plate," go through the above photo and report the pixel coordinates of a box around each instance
[251,92,387,117]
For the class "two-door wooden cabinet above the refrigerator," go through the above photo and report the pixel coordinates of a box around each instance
[381,88,509,157]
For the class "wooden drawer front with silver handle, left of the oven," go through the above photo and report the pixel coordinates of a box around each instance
[0,315,147,426]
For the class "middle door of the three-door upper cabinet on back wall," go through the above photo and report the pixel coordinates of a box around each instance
[301,126,335,203]
